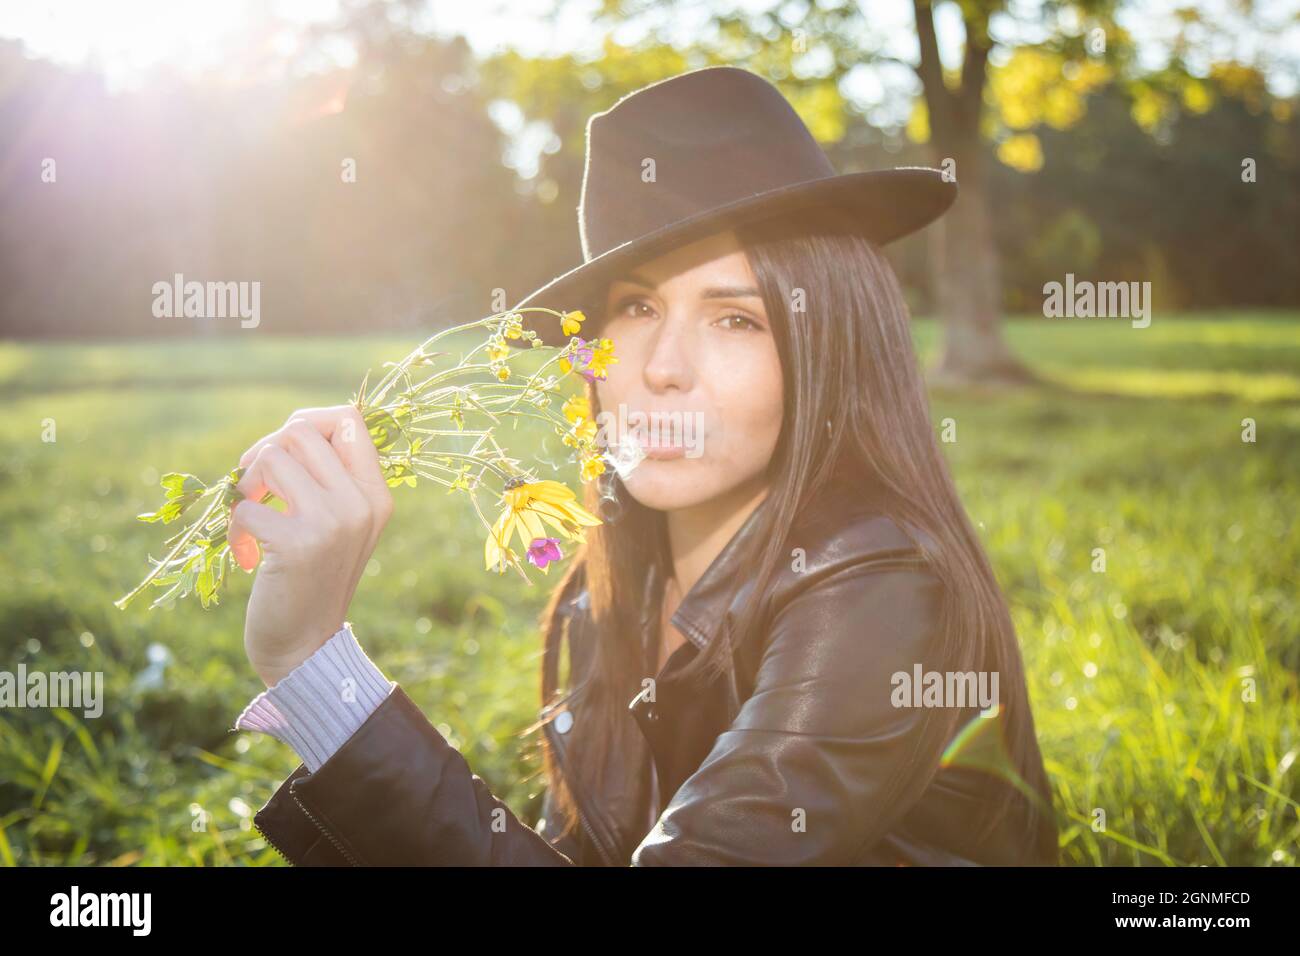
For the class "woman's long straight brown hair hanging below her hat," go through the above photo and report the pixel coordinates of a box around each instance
[525,211,1057,860]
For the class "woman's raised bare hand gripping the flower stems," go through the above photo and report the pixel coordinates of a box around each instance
[229,405,393,687]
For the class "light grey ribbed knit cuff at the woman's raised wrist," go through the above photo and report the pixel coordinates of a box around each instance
[235,622,397,773]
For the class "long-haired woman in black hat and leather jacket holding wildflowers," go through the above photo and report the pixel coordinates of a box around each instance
[230,68,1057,865]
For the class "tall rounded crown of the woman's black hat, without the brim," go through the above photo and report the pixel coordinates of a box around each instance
[577,66,835,261]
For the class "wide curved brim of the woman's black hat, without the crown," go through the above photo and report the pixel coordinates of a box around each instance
[506,166,957,347]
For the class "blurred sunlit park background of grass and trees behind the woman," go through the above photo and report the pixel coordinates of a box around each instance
[0,0,1300,866]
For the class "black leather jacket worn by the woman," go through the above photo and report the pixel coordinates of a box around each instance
[254,470,1056,866]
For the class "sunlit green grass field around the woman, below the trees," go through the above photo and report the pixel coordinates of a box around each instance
[0,313,1300,866]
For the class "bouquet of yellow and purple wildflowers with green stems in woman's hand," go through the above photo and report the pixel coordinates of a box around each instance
[114,308,619,609]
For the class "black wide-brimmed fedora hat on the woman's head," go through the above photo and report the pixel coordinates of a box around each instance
[506,66,957,346]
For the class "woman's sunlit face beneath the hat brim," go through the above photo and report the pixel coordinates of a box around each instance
[595,232,783,511]
